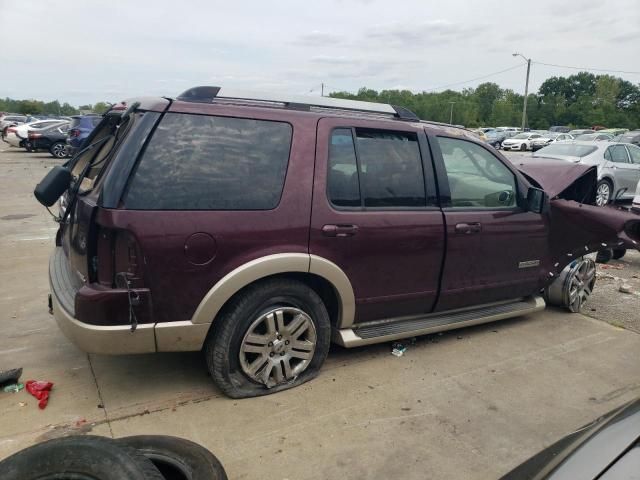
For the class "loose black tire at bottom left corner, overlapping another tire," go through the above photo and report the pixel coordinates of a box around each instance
[0,435,165,480]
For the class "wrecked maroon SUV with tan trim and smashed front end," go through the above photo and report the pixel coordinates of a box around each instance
[36,87,640,397]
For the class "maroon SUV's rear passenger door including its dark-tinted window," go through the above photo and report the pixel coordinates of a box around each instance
[309,118,445,322]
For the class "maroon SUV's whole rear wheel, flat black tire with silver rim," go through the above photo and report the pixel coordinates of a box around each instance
[205,278,331,398]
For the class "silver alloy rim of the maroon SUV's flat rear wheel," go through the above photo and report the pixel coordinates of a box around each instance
[240,307,316,388]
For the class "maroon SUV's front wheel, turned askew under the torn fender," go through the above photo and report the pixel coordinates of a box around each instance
[545,257,596,313]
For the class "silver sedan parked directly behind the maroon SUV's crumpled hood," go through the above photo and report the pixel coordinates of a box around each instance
[533,141,640,206]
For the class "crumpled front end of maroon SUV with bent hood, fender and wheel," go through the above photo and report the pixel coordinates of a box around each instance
[516,159,640,312]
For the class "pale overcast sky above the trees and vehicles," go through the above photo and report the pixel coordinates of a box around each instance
[0,0,640,105]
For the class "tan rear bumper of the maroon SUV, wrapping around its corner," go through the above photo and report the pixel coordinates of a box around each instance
[49,247,211,355]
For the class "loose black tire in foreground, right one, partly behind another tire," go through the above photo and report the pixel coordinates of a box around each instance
[116,435,227,480]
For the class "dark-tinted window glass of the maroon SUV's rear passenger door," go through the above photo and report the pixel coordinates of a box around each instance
[327,128,426,208]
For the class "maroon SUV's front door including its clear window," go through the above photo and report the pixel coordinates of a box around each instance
[429,136,549,311]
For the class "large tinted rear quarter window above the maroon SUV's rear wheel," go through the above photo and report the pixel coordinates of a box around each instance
[124,113,292,210]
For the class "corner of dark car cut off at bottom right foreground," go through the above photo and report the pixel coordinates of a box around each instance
[500,399,640,480]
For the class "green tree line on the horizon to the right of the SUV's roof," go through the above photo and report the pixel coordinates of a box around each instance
[330,72,640,129]
